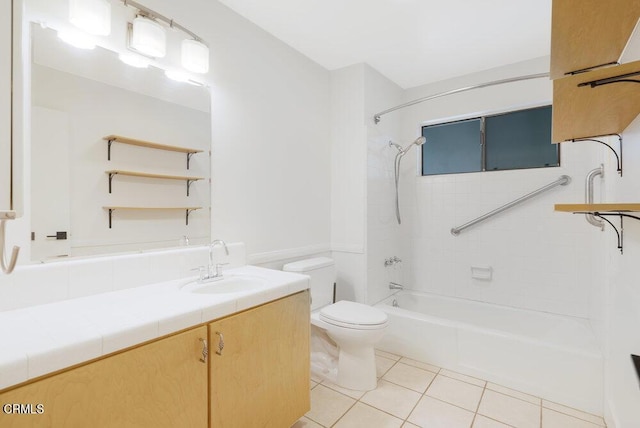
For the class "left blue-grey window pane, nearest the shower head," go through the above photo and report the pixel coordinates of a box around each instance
[422,119,482,175]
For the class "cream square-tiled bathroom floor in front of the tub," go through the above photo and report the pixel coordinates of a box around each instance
[292,351,605,428]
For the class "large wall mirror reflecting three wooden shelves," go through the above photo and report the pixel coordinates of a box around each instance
[23,0,211,261]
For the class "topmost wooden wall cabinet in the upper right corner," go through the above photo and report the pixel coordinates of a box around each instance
[551,0,640,79]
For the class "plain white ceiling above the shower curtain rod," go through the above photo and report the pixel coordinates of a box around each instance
[220,0,551,88]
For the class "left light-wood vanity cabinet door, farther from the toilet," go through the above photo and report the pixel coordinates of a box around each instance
[0,326,208,428]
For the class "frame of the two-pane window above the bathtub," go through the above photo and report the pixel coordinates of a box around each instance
[416,100,562,177]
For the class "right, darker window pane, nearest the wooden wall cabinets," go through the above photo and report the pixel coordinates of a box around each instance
[485,106,559,171]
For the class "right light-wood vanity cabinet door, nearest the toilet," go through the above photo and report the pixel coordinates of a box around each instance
[209,291,311,428]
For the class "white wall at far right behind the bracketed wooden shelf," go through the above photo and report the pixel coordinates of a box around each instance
[602,114,640,428]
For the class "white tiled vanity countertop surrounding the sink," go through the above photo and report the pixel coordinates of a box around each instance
[0,266,309,389]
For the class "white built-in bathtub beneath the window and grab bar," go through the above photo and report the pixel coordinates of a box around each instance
[376,291,603,415]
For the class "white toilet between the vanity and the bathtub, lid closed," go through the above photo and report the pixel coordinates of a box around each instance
[283,257,387,391]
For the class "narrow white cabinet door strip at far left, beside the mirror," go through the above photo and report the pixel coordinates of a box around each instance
[0,1,13,211]
